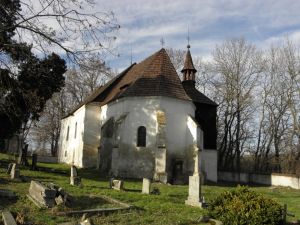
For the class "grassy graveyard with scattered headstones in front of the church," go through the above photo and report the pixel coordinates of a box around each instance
[0,154,300,225]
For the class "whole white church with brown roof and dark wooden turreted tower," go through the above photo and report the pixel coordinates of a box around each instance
[58,45,218,184]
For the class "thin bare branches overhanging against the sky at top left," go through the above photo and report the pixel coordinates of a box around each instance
[0,0,120,69]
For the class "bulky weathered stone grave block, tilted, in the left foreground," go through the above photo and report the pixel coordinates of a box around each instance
[29,181,57,208]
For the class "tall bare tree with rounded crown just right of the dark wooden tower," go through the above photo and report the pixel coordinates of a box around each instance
[213,39,263,171]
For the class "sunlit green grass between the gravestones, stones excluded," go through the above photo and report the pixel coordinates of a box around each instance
[0,154,300,225]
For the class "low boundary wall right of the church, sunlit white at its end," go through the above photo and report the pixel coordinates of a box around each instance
[218,171,300,189]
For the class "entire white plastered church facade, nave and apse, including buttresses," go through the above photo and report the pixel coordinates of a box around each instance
[59,96,217,182]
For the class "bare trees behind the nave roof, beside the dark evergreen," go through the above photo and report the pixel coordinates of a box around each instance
[30,60,113,156]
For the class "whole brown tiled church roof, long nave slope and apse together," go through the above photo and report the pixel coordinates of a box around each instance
[67,48,192,116]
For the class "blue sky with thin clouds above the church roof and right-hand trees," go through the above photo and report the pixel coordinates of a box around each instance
[94,0,300,71]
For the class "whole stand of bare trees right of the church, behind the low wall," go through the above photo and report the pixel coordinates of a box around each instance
[168,38,300,174]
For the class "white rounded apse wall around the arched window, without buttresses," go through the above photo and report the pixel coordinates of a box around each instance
[100,97,195,177]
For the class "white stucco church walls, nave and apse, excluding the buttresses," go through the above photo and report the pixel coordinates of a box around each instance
[59,97,217,181]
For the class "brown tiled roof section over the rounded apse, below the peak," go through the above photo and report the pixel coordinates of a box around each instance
[115,48,191,100]
